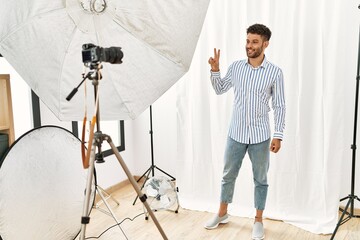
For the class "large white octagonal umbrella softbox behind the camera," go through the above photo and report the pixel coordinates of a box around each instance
[0,0,209,120]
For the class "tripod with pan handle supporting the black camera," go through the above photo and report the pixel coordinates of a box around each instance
[66,63,168,240]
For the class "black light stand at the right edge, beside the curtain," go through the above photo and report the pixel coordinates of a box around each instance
[330,23,360,240]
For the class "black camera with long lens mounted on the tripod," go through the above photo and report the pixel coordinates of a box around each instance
[82,43,124,64]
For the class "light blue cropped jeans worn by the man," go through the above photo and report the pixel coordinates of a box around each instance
[220,137,270,210]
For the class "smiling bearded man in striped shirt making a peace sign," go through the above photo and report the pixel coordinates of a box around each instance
[205,24,285,240]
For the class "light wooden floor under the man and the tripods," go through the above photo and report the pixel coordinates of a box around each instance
[86,184,360,240]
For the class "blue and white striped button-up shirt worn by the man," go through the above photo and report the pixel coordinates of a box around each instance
[210,58,285,144]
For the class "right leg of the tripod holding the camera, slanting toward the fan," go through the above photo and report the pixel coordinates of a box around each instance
[105,136,168,240]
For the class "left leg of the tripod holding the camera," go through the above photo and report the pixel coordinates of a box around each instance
[80,139,96,240]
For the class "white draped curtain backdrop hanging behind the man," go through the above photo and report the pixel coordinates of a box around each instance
[176,0,360,234]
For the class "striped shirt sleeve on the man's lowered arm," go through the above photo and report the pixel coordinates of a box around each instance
[272,70,286,140]
